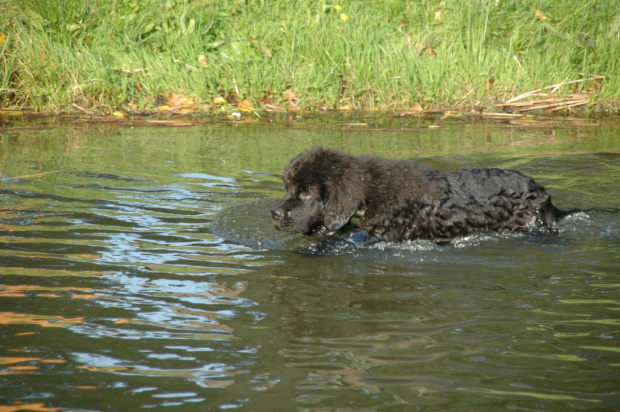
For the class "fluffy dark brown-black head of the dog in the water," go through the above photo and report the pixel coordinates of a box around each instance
[271,147,364,234]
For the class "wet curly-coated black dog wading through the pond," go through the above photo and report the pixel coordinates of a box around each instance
[271,148,566,243]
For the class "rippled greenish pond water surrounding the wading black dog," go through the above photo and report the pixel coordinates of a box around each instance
[0,117,620,411]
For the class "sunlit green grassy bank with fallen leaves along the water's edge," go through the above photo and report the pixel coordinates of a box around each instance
[0,0,620,113]
